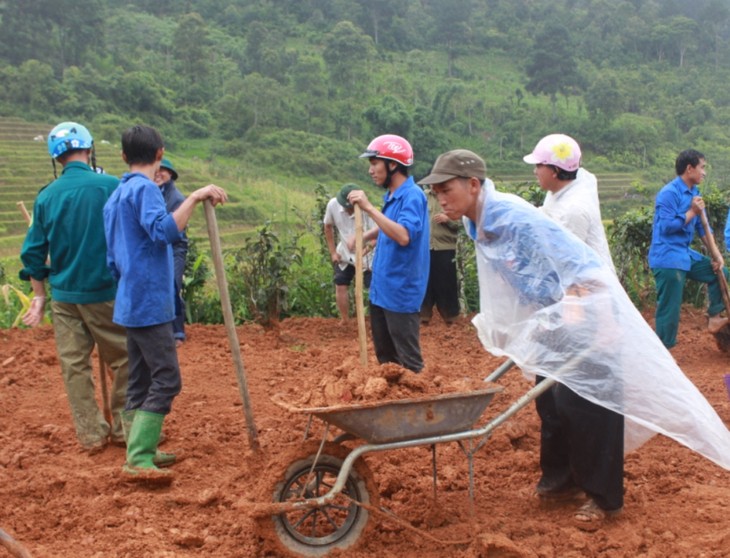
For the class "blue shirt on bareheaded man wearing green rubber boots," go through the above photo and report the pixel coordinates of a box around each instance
[104,172,182,327]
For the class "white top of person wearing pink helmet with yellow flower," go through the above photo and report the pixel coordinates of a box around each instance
[540,168,616,272]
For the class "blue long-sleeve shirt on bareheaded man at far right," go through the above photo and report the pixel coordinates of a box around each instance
[649,176,705,271]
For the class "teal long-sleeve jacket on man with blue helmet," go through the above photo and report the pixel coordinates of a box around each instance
[20,162,119,304]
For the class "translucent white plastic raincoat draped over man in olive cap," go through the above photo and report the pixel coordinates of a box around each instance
[467,180,730,470]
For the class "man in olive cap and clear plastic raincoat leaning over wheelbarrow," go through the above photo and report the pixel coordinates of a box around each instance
[420,149,730,526]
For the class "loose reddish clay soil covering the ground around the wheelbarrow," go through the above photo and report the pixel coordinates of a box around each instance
[0,309,730,558]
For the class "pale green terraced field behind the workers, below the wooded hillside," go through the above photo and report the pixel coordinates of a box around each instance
[0,118,648,257]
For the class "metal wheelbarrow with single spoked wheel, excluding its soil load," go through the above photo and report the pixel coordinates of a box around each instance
[255,360,555,556]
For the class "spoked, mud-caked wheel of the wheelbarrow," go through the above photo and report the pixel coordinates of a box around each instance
[264,443,378,556]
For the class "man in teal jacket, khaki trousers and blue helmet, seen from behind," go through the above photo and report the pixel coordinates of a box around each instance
[20,122,128,454]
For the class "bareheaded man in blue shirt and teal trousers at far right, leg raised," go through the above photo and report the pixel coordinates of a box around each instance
[649,149,728,349]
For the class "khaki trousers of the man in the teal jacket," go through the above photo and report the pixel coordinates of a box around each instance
[51,301,129,448]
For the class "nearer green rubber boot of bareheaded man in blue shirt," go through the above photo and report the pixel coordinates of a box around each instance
[122,410,172,483]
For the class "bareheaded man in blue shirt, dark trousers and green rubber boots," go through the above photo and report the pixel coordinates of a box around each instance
[104,125,228,482]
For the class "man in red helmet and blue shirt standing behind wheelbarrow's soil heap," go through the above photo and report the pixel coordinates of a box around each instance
[347,134,429,372]
